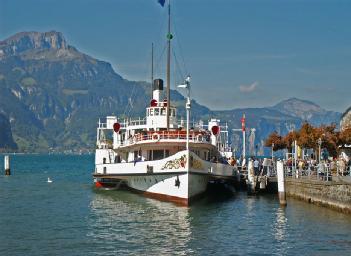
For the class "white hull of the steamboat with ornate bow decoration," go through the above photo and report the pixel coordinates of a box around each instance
[94,151,234,205]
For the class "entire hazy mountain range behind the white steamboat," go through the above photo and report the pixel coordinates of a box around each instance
[0,31,340,152]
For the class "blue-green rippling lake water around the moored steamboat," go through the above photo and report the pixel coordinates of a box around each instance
[0,155,351,255]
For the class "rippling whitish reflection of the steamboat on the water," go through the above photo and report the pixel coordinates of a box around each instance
[87,191,191,255]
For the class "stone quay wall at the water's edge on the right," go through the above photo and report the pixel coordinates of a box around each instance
[285,177,351,214]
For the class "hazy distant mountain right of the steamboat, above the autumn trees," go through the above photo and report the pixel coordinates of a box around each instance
[218,98,341,155]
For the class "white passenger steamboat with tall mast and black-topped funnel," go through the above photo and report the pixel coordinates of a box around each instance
[93,0,237,205]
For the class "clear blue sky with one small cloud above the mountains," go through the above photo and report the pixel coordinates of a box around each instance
[0,0,351,112]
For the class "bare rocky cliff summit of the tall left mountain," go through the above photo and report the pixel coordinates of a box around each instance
[0,31,68,58]
